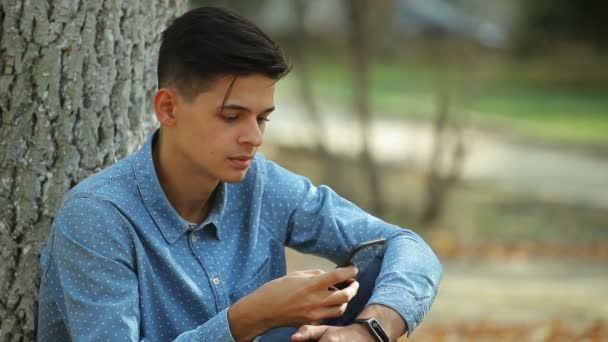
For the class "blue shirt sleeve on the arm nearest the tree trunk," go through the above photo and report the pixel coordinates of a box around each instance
[52,196,234,341]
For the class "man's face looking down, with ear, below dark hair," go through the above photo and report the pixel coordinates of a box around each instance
[167,75,275,182]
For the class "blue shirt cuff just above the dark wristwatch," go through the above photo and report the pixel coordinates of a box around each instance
[367,286,425,337]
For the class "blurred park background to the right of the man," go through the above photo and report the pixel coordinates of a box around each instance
[191,0,608,341]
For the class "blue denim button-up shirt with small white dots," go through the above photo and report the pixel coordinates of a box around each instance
[38,130,441,342]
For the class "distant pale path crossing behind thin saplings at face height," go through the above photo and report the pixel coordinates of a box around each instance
[266,101,608,208]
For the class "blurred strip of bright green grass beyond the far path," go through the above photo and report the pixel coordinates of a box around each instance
[286,56,608,145]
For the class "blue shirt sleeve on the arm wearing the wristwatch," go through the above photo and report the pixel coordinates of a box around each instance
[258,161,442,334]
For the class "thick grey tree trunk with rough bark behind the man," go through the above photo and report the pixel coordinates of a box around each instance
[0,0,187,341]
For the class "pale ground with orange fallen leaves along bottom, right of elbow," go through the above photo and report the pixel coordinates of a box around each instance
[287,250,608,341]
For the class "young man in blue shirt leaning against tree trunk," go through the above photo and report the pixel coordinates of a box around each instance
[38,8,441,341]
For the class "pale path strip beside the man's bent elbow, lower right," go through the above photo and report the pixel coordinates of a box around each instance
[287,249,608,325]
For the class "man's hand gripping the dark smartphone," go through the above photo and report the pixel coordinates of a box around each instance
[228,266,359,341]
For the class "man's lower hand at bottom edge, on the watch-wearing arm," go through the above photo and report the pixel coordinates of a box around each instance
[291,324,376,342]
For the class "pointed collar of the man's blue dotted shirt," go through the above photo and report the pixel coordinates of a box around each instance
[133,130,227,244]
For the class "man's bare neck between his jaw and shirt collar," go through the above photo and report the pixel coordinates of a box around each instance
[152,132,219,224]
